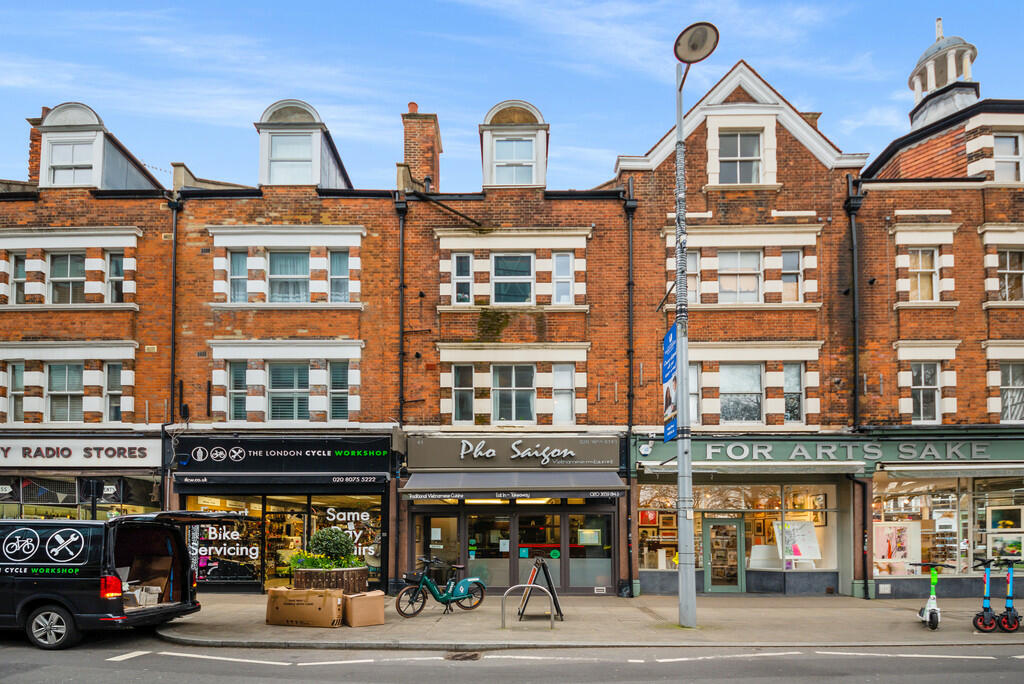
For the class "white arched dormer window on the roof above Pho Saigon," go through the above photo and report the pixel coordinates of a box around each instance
[480,99,548,185]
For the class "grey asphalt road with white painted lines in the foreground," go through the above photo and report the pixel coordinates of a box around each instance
[0,633,1024,684]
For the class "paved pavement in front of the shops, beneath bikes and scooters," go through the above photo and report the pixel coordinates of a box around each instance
[151,593,1024,651]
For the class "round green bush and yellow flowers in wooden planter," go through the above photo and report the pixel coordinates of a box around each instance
[290,527,370,594]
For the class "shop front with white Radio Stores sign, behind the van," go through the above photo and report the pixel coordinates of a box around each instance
[0,434,162,520]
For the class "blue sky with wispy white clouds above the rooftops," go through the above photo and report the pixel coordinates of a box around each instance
[0,0,1024,193]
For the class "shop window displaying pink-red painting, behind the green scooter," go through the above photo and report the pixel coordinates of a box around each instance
[872,479,970,576]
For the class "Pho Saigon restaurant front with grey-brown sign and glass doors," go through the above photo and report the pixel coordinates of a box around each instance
[400,434,626,594]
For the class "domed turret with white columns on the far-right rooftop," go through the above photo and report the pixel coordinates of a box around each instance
[907,17,980,129]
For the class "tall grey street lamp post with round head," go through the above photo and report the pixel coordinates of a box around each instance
[675,22,718,627]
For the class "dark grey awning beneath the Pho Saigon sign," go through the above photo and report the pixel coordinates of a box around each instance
[401,470,626,499]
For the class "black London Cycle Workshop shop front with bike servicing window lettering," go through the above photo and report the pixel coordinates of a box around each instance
[174,434,391,591]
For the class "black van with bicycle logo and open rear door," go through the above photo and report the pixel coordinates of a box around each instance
[0,511,243,649]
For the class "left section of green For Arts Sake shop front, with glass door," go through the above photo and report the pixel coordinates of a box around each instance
[633,437,865,595]
